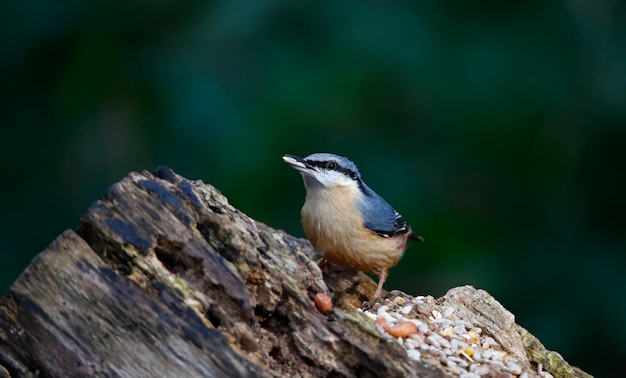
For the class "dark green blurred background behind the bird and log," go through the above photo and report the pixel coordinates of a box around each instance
[0,0,626,376]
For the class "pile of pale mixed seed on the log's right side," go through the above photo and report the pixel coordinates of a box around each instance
[359,297,552,378]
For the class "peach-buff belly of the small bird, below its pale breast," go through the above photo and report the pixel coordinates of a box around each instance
[302,202,408,273]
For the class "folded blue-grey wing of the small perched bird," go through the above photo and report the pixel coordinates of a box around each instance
[358,187,408,237]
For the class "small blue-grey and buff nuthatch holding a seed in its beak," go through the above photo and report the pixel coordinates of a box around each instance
[283,153,424,303]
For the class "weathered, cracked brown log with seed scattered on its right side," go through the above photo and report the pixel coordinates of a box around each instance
[0,168,588,377]
